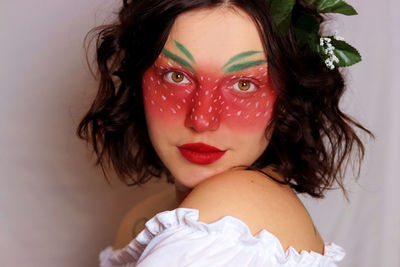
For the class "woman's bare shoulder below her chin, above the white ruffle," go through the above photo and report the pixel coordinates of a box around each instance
[179,170,324,254]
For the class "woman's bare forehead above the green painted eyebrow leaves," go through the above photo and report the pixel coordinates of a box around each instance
[164,6,266,67]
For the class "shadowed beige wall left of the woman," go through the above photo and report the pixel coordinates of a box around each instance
[0,0,169,267]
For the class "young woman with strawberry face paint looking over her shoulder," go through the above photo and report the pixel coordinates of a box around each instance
[78,0,368,266]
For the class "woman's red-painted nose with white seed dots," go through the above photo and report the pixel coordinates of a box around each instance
[185,86,221,132]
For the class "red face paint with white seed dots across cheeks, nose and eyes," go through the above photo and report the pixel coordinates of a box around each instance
[143,56,276,132]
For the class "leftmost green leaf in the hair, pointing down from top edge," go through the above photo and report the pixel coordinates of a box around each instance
[270,0,296,35]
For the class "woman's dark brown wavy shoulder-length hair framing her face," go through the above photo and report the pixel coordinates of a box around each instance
[77,0,372,198]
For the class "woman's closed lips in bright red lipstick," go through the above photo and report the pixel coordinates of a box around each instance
[178,143,226,165]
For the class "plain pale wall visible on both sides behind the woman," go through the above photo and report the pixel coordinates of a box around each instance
[0,0,400,267]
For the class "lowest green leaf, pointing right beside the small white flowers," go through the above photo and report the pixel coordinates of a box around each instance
[331,37,361,67]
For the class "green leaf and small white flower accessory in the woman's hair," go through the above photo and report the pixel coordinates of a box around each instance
[266,0,361,70]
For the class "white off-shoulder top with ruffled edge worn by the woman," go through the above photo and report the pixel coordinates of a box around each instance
[100,208,345,267]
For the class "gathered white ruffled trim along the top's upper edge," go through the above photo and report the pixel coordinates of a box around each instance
[100,208,345,266]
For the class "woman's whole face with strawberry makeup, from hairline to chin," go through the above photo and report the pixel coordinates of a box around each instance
[143,7,276,188]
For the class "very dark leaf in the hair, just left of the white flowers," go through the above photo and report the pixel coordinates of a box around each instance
[294,15,319,47]
